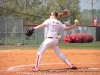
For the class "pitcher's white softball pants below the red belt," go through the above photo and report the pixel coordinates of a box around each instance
[35,38,71,68]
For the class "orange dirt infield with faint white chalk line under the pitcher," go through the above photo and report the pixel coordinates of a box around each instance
[0,50,100,75]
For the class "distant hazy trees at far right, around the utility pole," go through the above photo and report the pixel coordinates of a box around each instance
[80,9,100,25]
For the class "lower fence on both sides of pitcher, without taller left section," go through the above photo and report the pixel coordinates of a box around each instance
[24,25,100,45]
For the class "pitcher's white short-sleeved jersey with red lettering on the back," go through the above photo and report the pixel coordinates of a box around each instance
[43,19,66,37]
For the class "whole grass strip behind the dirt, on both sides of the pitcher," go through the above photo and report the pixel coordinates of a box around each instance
[0,42,100,50]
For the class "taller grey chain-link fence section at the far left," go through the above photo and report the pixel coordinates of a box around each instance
[0,17,24,44]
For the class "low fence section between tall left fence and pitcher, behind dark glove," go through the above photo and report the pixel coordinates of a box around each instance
[24,25,44,45]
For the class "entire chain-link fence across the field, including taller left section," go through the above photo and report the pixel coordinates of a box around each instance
[0,17,100,45]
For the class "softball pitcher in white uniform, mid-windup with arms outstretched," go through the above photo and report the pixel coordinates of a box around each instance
[32,9,77,71]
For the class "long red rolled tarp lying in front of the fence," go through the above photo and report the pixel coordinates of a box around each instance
[64,33,94,43]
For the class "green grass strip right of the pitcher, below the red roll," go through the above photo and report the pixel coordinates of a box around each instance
[60,42,100,50]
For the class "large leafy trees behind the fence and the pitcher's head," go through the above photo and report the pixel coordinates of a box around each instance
[0,0,100,24]
